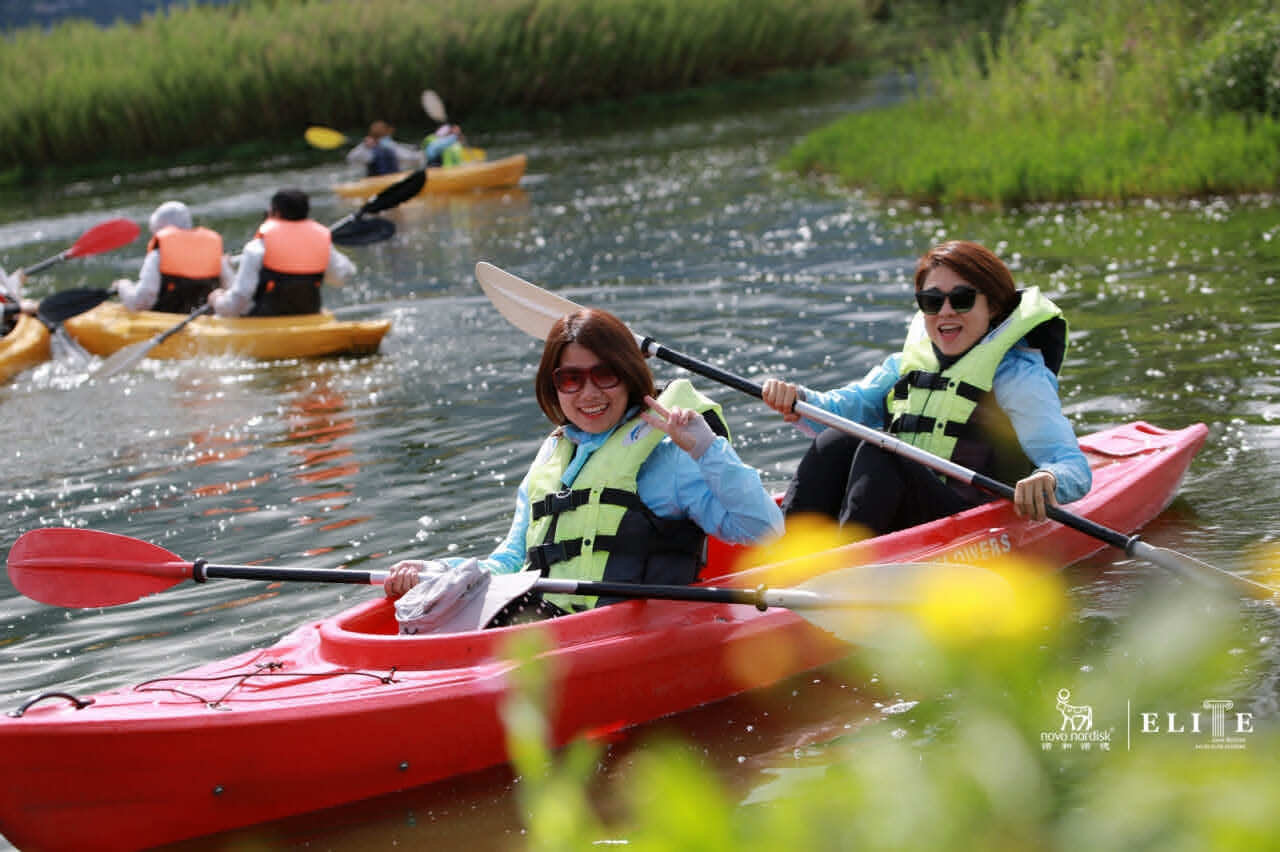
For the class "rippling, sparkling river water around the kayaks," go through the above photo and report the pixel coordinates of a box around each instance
[0,76,1280,849]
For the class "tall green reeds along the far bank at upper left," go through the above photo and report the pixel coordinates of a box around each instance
[0,0,861,174]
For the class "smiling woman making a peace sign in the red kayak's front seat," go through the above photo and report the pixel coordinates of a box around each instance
[384,308,782,624]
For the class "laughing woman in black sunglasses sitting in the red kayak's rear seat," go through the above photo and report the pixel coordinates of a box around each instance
[762,241,1092,535]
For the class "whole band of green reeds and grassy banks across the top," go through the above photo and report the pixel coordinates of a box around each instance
[0,0,1280,206]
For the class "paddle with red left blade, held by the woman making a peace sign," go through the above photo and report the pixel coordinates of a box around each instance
[9,527,1011,637]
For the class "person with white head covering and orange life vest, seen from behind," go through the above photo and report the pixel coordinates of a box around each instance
[111,201,236,313]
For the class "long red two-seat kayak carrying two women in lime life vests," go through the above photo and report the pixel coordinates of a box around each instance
[0,422,1207,852]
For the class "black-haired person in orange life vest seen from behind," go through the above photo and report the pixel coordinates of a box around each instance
[209,189,356,316]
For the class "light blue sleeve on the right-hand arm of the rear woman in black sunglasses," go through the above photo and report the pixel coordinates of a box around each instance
[992,347,1093,503]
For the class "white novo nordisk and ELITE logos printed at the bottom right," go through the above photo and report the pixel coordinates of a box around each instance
[1041,688,1253,751]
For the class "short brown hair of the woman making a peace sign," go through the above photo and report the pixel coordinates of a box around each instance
[534,308,658,426]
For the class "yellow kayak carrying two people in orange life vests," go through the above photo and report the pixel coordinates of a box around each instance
[63,302,392,361]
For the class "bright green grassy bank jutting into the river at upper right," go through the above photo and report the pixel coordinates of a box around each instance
[785,0,1280,206]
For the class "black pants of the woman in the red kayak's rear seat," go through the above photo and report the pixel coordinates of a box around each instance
[782,429,973,535]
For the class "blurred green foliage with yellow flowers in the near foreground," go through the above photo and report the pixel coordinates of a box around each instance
[506,557,1280,852]
